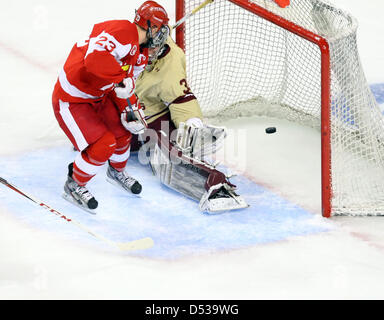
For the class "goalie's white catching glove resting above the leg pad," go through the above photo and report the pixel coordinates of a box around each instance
[176,118,227,159]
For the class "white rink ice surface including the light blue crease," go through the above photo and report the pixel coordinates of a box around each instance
[0,0,384,299]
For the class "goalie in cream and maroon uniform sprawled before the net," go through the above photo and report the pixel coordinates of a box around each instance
[131,33,248,212]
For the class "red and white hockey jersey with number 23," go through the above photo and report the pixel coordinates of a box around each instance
[53,20,148,103]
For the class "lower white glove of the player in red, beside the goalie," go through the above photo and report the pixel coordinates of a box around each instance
[121,96,148,134]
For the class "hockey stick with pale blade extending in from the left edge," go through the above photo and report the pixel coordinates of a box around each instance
[0,177,154,251]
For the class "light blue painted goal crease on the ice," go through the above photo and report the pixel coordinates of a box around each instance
[0,146,330,259]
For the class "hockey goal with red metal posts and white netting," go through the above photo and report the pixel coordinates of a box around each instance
[176,0,384,217]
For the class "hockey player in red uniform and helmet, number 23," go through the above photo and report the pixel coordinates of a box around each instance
[52,1,169,211]
